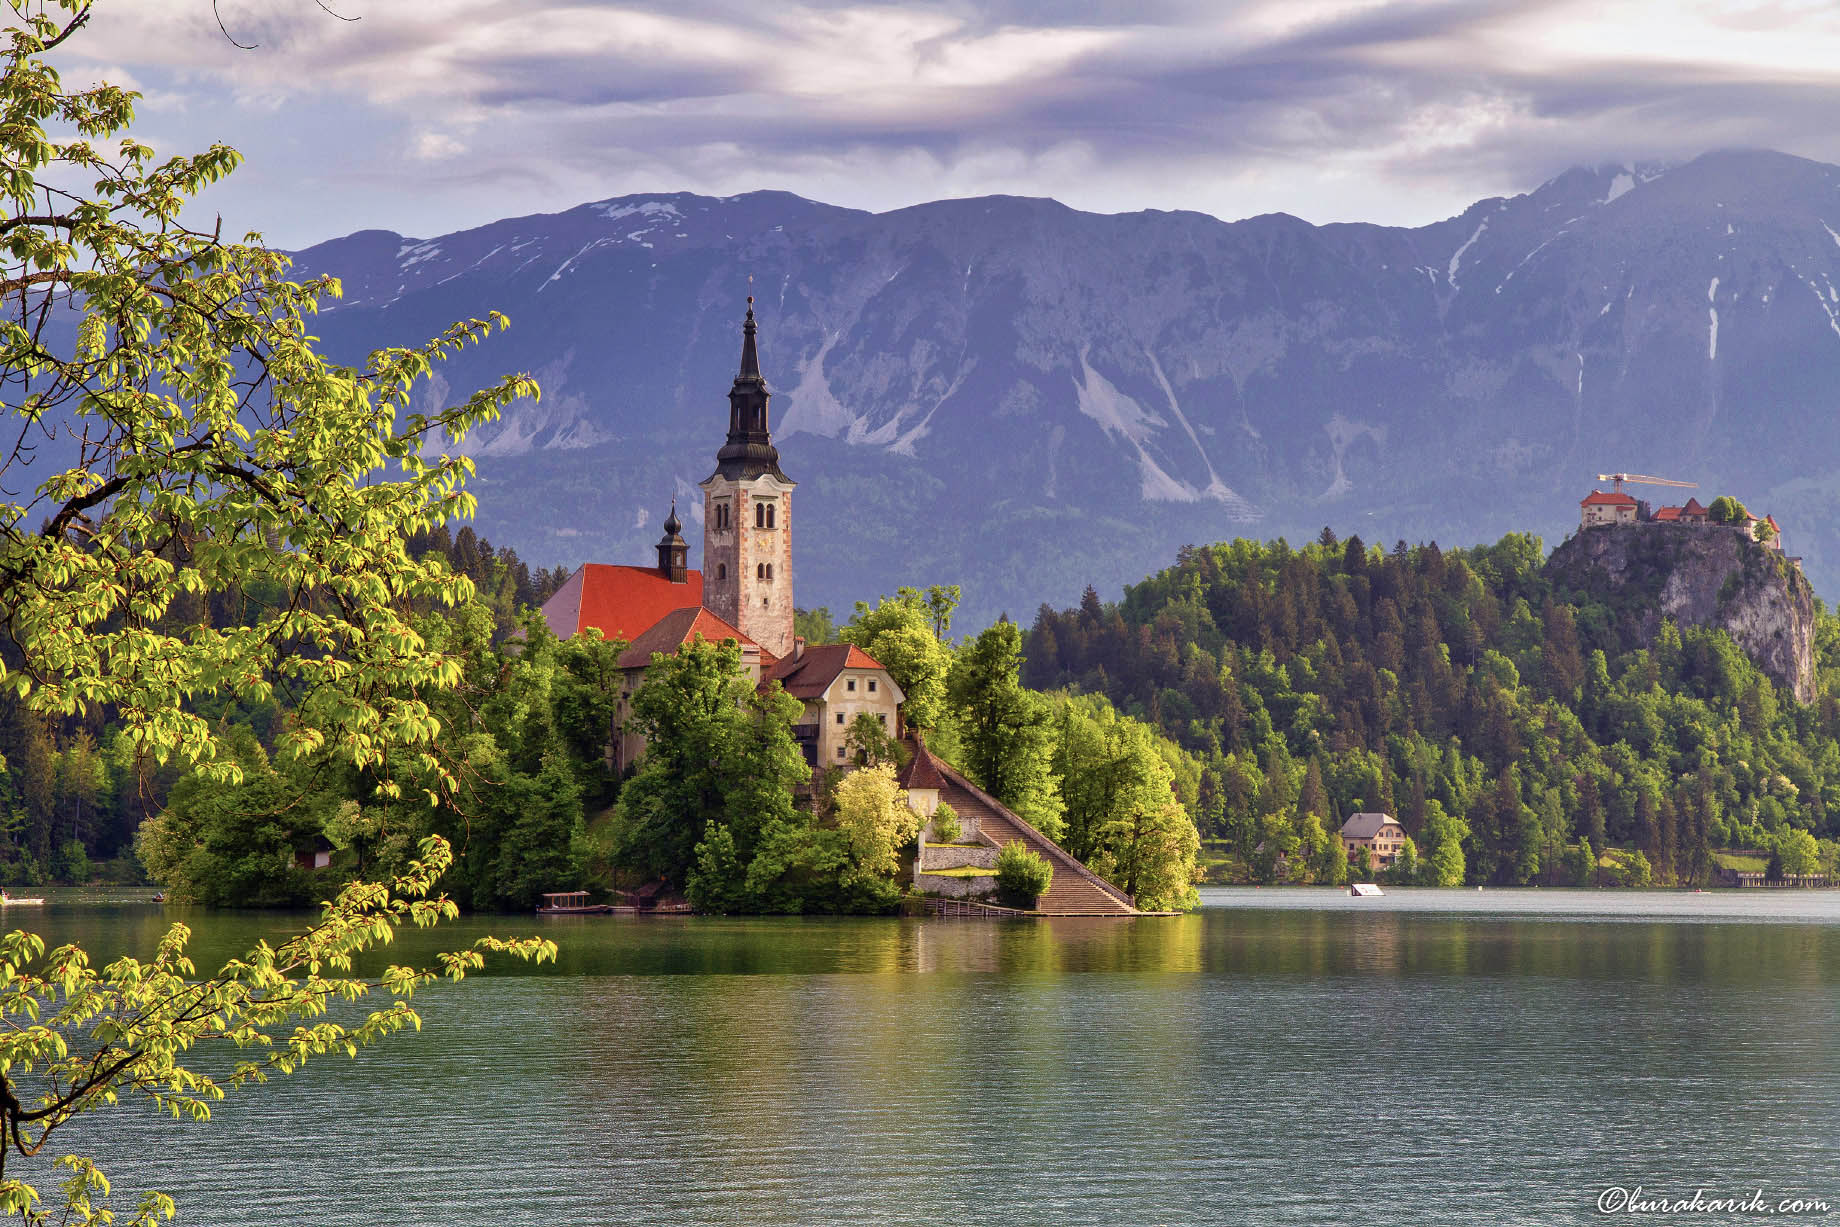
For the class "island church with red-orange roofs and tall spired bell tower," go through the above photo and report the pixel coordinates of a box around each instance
[543,298,905,771]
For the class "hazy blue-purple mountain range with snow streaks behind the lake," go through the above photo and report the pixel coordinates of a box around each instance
[296,151,1840,629]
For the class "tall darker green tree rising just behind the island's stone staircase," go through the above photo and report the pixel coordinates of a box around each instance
[949,618,1064,841]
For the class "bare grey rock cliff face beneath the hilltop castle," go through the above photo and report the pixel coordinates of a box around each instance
[1546,524,1814,703]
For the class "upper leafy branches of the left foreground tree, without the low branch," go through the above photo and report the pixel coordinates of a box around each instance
[0,0,537,789]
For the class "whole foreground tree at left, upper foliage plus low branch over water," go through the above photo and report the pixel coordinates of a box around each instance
[0,9,554,1221]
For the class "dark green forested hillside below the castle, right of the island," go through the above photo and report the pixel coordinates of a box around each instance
[1027,528,1840,885]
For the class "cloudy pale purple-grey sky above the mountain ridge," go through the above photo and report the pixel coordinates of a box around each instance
[57,0,1840,248]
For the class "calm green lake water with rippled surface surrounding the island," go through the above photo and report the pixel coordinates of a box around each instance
[7,890,1840,1225]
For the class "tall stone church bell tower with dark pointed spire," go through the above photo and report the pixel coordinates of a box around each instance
[703,296,797,657]
